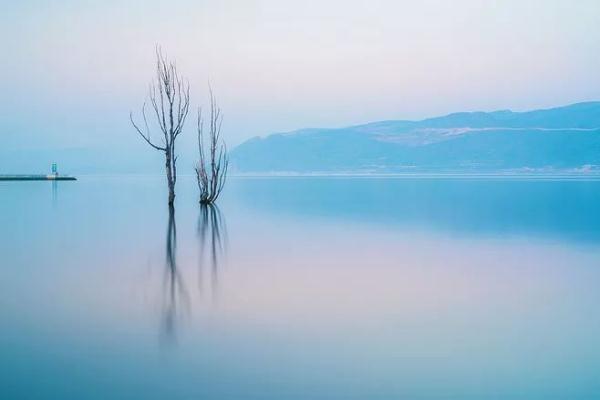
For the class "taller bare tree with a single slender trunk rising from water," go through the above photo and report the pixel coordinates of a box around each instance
[129,46,190,205]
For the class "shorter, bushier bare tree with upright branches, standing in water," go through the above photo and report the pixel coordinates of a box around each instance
[196,89,229,204]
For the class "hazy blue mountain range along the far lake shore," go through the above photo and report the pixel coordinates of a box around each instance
[231,102,600,173]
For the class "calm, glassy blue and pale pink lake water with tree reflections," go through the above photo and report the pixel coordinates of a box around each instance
[0,177,600,399]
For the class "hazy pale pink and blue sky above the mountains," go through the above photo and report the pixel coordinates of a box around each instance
[0,0,600,167]
